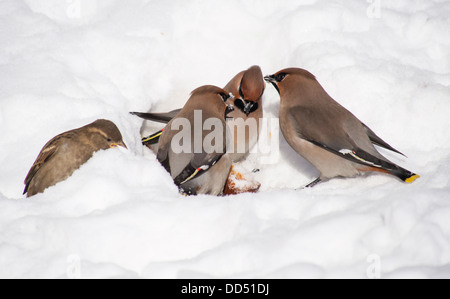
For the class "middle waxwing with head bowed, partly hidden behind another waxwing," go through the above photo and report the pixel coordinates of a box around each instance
[131,65,266,162]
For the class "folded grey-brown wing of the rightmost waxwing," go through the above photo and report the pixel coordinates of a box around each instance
[288,107,398,170]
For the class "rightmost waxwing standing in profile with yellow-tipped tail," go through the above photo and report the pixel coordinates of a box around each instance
[265,68,419,187]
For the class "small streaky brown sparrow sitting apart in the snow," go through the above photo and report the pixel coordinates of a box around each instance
[23,119,126,197]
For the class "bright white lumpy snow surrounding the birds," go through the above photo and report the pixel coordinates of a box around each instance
[0,0,450,278]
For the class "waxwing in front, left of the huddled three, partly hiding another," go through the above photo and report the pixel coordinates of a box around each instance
[157,85,233,195]
